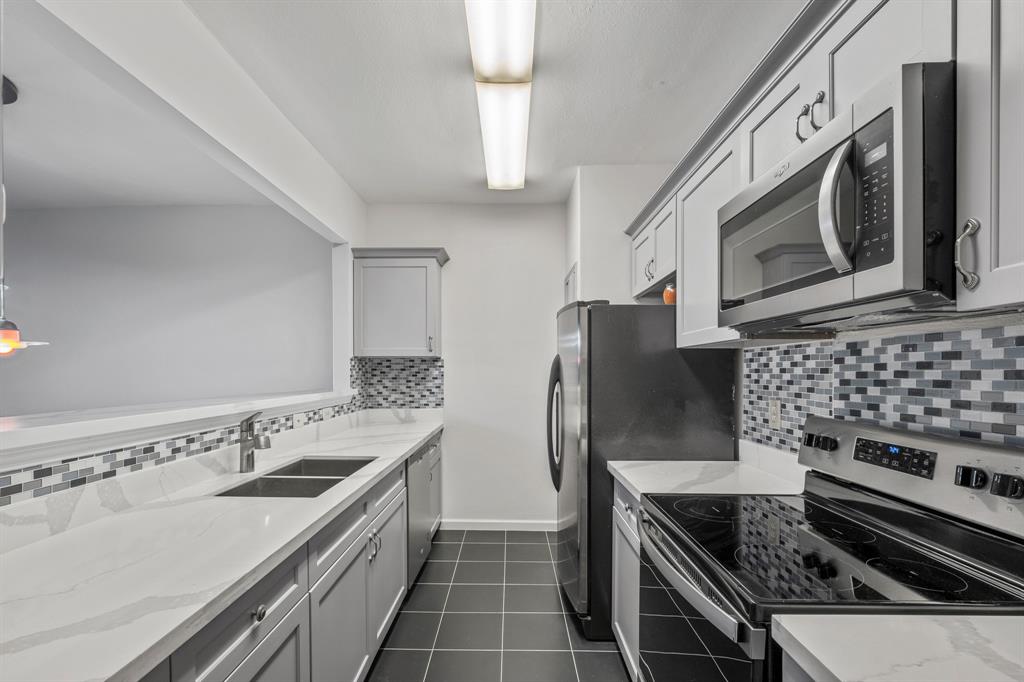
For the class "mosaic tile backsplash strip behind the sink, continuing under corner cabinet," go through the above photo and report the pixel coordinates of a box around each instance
[0,357,444,507]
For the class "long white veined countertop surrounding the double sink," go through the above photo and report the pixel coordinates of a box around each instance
[0,411,442,682]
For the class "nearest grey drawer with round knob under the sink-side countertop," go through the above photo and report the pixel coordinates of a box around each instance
[171,546,309,682]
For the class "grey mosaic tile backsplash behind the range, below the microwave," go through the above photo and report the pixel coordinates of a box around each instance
[742,323,1024,453]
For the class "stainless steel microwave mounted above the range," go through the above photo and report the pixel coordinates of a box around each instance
[718,62,956,334]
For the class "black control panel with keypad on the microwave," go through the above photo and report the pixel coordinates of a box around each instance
[854,109,895,271]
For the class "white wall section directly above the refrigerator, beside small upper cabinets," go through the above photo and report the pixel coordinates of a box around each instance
[566,164,672,303]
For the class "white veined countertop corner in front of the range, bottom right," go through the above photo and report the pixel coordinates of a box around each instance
[772,614,1024,682]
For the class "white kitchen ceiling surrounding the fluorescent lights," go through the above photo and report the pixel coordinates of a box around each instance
[188,0,805,203]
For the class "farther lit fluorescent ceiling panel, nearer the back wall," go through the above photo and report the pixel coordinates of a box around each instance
[476,83,532,189]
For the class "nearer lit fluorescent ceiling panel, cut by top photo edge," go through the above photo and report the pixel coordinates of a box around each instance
[466,0,537,83]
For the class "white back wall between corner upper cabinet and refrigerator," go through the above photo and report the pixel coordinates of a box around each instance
[367,205,565,528]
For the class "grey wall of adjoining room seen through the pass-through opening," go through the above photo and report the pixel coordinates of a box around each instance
[0,206,331,416]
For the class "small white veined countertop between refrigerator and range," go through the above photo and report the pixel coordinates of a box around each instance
[608,460,804,498]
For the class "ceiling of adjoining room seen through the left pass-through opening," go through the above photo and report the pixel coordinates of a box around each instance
[3,3,269,209]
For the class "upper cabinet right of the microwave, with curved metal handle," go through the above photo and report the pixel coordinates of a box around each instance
[956,0,1024,310]
